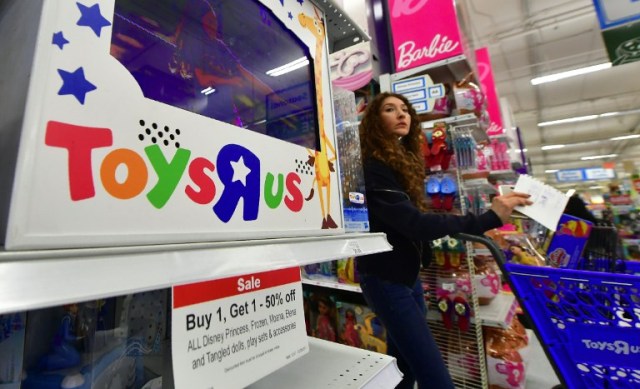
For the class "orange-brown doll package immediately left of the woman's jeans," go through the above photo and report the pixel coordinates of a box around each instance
[336,301,387,354]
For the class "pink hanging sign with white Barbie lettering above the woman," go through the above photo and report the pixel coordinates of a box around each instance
[388,0,463,72]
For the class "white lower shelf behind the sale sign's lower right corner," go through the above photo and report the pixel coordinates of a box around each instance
[248,338,402,389]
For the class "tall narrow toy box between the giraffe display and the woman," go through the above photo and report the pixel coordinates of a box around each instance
[333,87,369,232]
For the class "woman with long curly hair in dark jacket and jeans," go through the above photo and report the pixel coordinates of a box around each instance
[357,93,531,389]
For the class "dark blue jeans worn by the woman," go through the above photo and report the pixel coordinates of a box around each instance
[360,274,454,389]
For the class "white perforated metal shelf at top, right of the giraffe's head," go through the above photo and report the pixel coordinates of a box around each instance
[315,0,371,53]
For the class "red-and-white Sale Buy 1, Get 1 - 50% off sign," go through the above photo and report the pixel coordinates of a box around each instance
[171,267,309,389]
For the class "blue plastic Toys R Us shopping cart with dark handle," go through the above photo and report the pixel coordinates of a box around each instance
[456,234,640,389]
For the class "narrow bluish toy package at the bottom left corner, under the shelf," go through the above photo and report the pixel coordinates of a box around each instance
[0,312,26,389]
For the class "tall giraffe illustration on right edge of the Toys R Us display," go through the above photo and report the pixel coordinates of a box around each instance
[298,8,338,229]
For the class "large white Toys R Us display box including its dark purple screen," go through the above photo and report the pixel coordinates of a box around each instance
[0,0,344,250]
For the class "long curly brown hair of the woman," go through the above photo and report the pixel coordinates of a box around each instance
[360,92,427,211]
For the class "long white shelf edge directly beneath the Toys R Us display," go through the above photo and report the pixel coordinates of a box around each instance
[0,233,391,313]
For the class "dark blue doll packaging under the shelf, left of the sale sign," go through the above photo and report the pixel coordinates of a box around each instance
[22,290,168,389]
